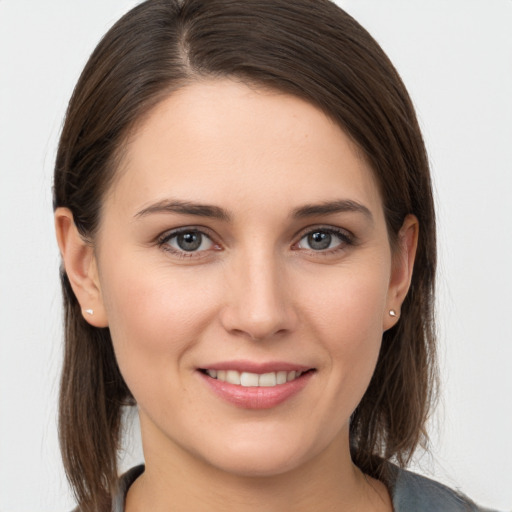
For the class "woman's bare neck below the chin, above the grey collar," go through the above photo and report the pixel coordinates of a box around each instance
[126,418,392,512]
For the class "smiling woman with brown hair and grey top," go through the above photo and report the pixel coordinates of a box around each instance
[54,0,496,512]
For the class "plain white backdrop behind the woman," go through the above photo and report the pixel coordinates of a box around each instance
[0,0,512,512]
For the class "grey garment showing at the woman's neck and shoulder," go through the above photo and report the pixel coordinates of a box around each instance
[112,465,496,512]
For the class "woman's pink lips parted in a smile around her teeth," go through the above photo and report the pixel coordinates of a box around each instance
[197,361,315,409]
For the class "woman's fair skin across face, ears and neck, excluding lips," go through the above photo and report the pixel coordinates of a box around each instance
[56,80,418,512]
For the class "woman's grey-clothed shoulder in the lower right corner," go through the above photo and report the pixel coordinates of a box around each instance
[392,468,500,512]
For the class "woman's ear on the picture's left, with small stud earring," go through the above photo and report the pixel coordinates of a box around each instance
[55,208,108,327]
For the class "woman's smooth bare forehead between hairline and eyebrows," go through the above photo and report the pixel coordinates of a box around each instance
[106,79,380,222]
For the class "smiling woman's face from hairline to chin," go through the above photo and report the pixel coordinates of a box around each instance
[89,80,407,475]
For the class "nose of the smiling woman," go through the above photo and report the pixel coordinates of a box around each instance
[221,248,298,340]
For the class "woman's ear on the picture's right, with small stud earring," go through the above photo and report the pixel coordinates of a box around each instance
[383,215,419,331]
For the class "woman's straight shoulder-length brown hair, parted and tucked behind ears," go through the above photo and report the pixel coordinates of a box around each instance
[54,0,436,511]
